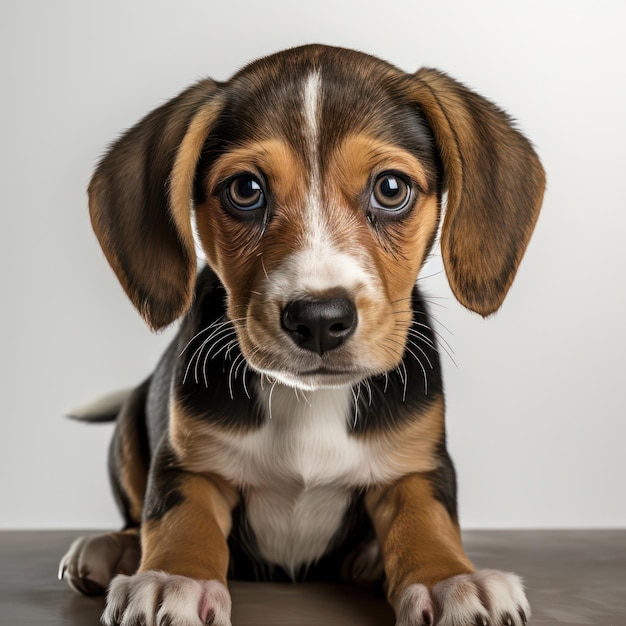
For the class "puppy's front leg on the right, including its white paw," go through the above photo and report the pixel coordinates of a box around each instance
[366,474,530,626]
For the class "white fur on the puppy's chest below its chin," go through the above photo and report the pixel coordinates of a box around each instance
[214,385,389,571]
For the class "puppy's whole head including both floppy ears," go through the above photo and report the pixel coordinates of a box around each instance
[89,46,544,388]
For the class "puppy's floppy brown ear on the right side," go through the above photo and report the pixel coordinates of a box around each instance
[412,69,545,316]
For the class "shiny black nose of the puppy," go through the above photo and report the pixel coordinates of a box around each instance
[282,298,357,355]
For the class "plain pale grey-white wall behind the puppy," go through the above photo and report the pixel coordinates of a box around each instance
[0,0,626,528]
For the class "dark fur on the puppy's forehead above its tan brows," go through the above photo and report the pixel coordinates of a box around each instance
[194,46,442,203]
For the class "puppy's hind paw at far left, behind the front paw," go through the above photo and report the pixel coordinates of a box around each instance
[59,532,141,595]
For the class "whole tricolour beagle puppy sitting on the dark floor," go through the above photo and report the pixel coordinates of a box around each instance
[60,45,545,626]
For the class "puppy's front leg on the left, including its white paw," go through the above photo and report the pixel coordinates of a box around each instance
[102,444,238,626]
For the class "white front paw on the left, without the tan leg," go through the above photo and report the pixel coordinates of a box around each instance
[102,571,231,626]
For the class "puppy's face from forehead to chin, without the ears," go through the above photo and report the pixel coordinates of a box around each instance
[195,59,439,387]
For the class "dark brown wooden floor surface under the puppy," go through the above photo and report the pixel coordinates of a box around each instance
[0,530,626,626]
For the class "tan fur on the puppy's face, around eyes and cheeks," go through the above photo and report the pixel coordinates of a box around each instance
[196,134,439,380]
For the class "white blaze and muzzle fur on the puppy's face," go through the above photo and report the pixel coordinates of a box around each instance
[243,72,387,390]
